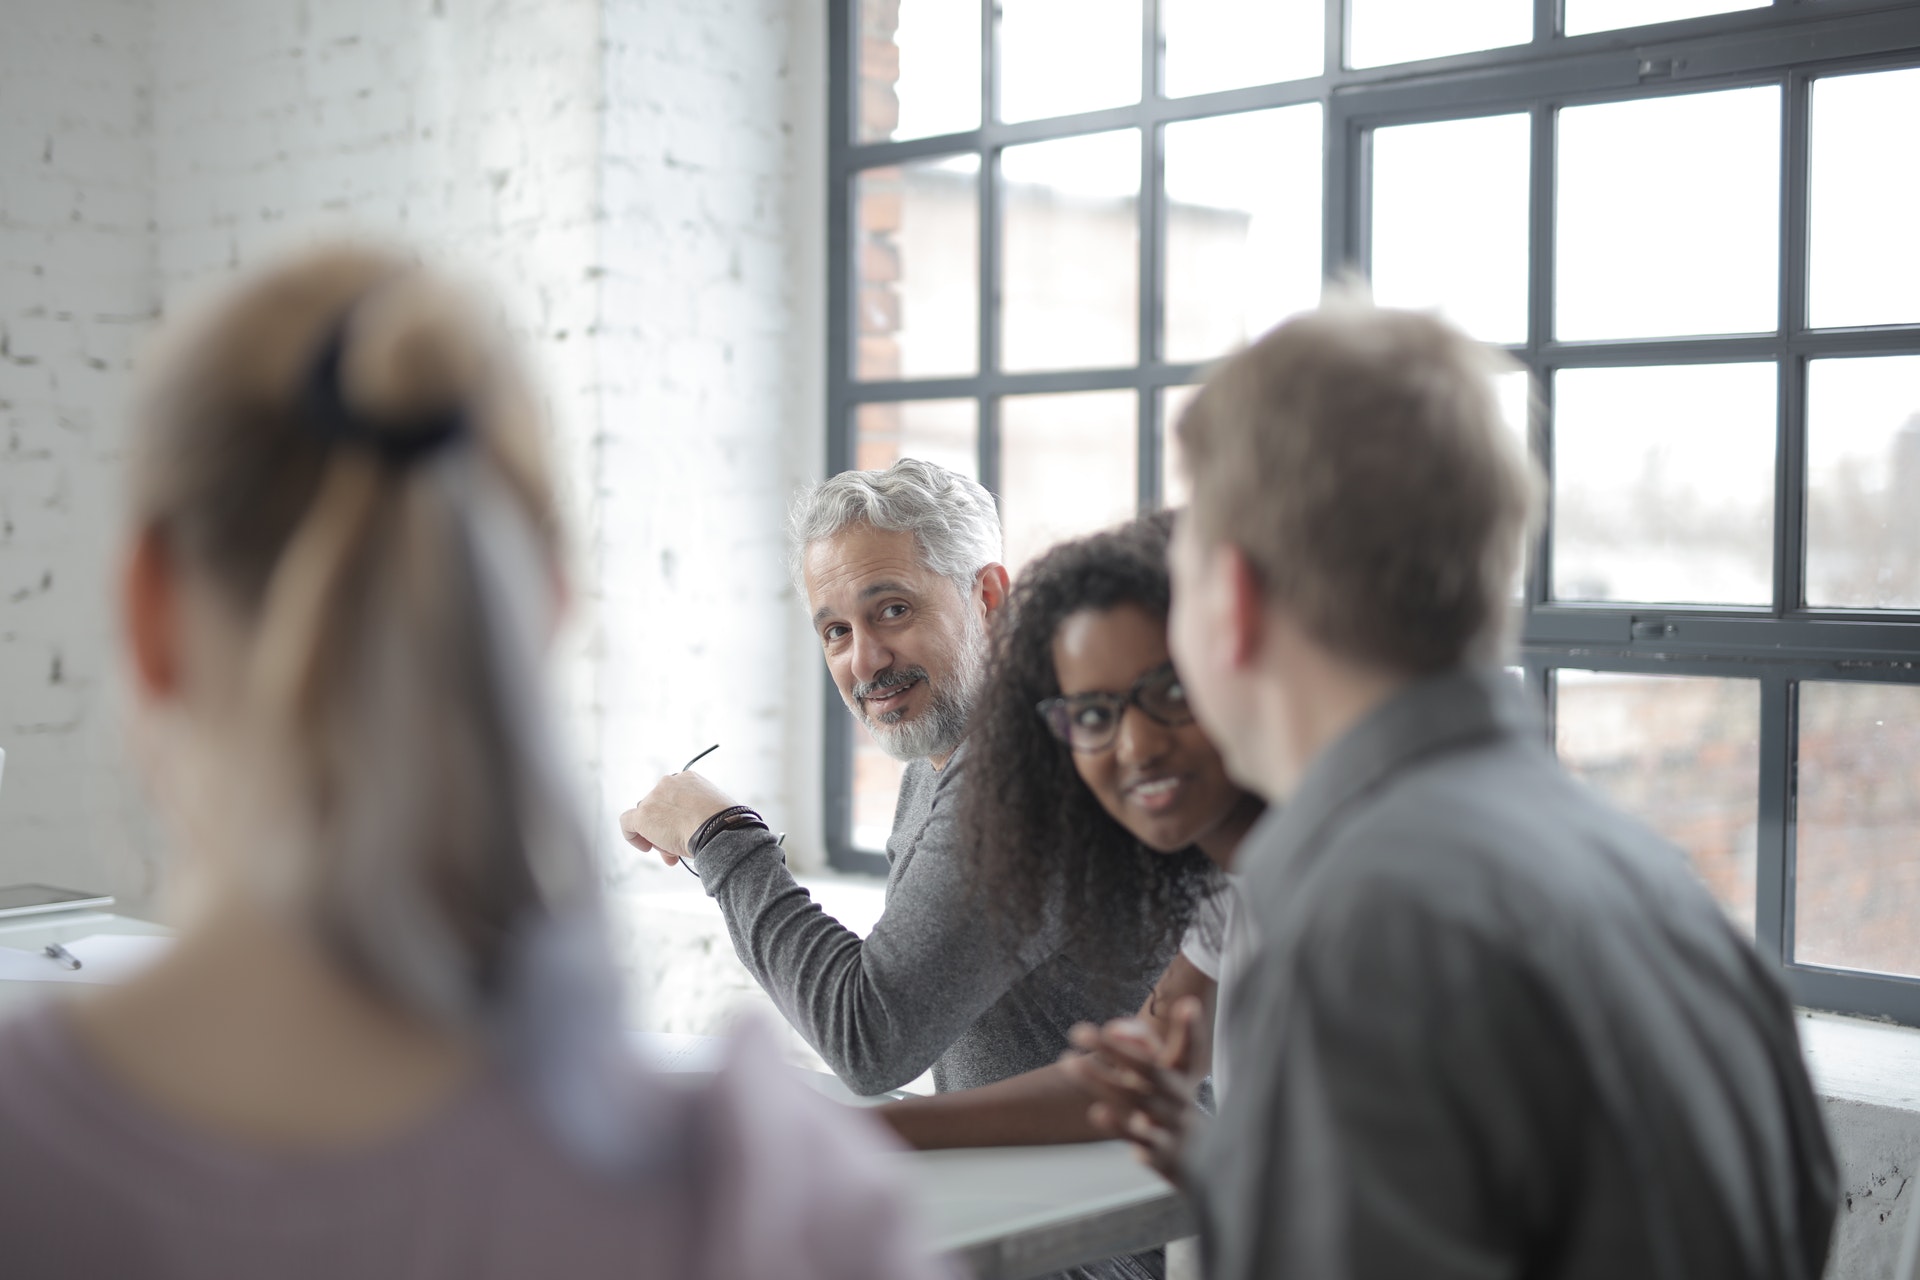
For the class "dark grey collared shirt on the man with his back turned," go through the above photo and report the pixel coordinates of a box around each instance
[1188,672,1836,1280]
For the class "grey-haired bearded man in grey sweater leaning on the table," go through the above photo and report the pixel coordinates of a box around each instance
[620,459,1167,1128]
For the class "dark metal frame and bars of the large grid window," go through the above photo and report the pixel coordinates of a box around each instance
[824,0,1920,1025]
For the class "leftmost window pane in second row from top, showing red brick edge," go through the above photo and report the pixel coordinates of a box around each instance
[854,155,979,378]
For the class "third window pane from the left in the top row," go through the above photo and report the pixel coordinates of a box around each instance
[1160,0,1327,98]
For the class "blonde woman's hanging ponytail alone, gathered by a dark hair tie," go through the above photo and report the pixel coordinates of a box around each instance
[250,276,555,1025]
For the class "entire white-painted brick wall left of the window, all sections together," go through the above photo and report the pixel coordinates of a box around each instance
[0,0,824,924]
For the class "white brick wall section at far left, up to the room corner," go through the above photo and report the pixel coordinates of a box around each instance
[0,0,157,900]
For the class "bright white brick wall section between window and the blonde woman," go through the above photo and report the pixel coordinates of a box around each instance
[599,0,826,887]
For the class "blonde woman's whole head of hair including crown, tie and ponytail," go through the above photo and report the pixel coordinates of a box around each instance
[136,251,656,1163]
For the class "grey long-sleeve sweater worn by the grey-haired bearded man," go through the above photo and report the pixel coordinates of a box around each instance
[695,745,1171,1094]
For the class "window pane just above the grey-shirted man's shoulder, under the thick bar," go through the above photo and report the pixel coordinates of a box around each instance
[1553,672,1761,938]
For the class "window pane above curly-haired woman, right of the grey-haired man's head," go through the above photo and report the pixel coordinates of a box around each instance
[1000,391,1140,574]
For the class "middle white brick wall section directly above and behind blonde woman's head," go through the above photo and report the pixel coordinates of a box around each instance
[154,0,599,871]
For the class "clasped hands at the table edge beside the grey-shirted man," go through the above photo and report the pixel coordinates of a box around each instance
[1062,996,1202,1182]
